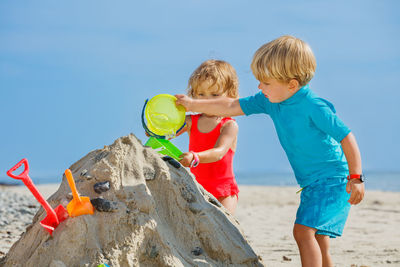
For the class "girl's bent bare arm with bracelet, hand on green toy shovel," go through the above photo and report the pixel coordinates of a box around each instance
[180,121,239,167]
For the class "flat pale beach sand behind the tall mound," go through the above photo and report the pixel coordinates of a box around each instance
[0,184,400,267]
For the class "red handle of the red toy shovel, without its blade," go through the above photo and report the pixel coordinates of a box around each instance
[7,158,58,223]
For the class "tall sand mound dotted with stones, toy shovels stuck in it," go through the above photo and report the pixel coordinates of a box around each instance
[0,134,263,267]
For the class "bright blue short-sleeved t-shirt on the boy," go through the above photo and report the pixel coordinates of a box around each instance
[239,85,350,187]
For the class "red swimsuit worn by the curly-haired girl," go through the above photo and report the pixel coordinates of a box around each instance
[189,114,239,198]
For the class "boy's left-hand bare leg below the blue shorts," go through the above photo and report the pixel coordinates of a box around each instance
[293,224,322,267]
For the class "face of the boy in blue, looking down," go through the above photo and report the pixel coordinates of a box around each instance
[258,79,299,103]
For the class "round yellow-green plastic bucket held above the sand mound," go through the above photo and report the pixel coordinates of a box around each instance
[142,94,186,138]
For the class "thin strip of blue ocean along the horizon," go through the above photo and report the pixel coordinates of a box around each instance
[0,172,400,192]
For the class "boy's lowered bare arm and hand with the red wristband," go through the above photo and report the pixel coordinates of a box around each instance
[341,133,365,205]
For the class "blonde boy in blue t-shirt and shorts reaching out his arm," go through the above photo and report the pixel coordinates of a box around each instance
[176,36,365,267]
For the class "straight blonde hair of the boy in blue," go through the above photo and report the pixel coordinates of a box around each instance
[251,35,317,86]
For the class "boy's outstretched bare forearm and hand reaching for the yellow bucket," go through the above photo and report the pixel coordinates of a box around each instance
[175,95,244,117]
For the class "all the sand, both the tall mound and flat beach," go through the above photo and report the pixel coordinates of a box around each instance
[0,134,400,267]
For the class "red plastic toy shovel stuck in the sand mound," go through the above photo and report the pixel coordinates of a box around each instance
[7,159,68,235]
